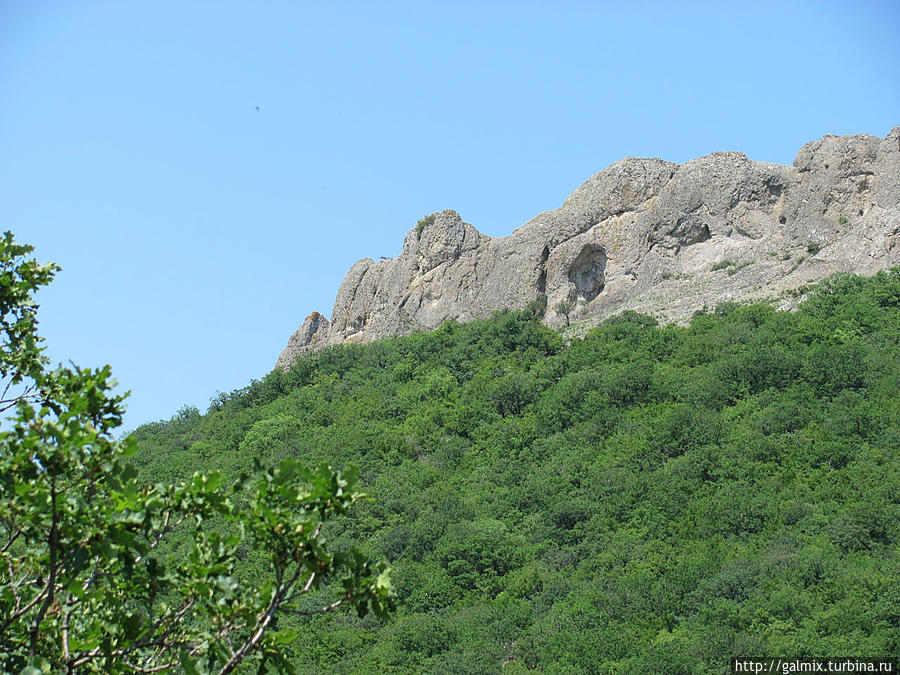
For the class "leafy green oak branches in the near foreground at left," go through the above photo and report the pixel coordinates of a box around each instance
[0,233,393,674]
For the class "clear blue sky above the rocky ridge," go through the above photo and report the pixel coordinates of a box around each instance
[0,0,900,427]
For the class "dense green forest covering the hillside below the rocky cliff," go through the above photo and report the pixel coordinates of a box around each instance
[134,268,900,673]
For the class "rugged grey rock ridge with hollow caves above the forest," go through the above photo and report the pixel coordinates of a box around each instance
[278,126,900,367]
